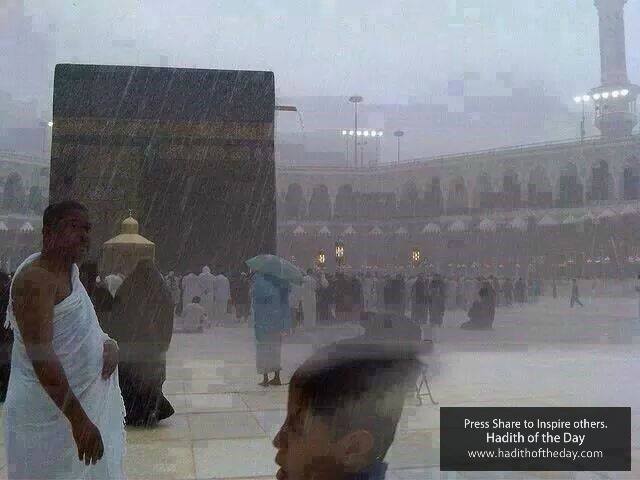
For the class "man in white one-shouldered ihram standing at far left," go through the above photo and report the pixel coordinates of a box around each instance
[4,201,126,480]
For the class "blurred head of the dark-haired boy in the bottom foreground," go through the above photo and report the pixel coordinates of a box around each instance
[273,343,420,480]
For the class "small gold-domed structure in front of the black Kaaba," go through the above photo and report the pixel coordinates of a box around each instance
[101,215,156,276]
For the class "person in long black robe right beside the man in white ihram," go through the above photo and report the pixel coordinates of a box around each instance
[108,259,174,426]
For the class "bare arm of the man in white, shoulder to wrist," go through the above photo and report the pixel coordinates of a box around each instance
[12,266,88,425]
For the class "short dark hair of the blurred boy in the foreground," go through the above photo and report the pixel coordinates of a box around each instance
[290,339,421,461]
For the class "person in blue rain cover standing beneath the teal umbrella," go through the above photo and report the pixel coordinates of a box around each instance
[252,273,291,387]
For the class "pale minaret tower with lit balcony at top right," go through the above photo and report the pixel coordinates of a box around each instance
[591,0,639,137]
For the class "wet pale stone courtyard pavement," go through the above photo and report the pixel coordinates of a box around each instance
[0,298,640,480]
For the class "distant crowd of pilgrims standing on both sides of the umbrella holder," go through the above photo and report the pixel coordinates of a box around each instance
[156,267,544,332]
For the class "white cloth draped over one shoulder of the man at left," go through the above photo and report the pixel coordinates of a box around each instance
[4,254,126,480]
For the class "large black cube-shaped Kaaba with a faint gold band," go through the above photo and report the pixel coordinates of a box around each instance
[50,64,276,272]
